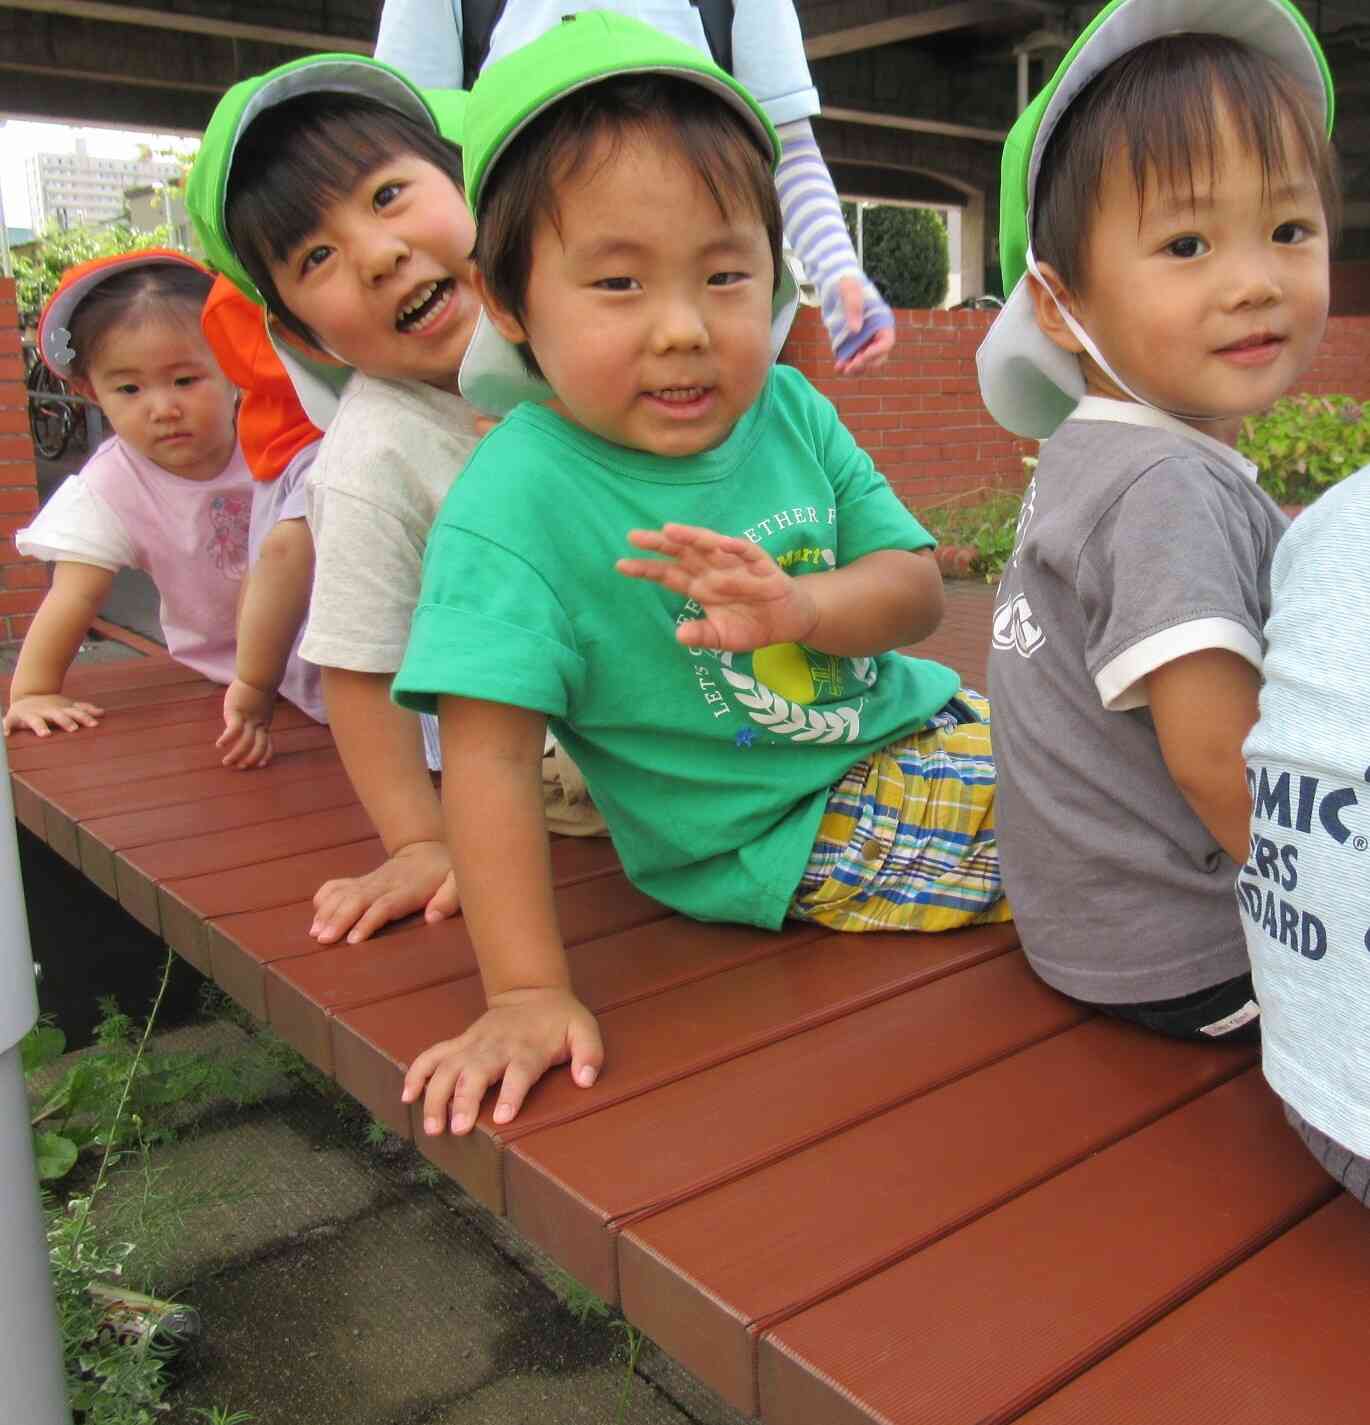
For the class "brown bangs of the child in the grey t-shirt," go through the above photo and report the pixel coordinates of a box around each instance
[1113,34,1336,233]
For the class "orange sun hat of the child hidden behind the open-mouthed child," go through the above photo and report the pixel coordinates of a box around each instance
[200,276,322,480]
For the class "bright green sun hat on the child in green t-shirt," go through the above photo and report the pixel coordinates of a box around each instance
[460,10,798,415]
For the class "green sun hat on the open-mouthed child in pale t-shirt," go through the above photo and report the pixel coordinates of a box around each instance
[185,54,468,430]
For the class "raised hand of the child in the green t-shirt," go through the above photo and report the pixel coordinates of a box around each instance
[616,524,818,653]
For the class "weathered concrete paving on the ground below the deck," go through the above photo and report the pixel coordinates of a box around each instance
[32,957,743,1425]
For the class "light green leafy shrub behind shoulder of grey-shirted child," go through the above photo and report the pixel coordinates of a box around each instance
[1237,396,1370,504]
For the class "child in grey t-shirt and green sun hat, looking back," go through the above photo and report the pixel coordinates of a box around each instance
[979,0,1336,1039]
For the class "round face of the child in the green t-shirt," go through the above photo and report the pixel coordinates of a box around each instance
[492,131,774,456]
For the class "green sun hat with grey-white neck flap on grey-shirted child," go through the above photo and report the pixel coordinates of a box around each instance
[975,0,1334,439]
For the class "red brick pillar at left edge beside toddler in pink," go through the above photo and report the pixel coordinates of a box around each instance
[0,278,47,643]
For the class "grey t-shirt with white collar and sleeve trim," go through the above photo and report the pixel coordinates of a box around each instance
[989,398,1289,1005]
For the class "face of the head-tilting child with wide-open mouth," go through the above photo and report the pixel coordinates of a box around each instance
[271,154,479,390]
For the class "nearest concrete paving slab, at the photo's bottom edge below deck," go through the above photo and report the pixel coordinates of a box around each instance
[172,1190,701,1425]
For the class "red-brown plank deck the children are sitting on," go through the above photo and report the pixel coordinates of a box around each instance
[9,587,1370,1425]
